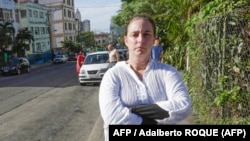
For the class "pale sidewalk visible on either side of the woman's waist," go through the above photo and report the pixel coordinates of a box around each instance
[87,114,198,141]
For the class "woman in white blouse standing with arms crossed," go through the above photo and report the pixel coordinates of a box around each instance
[99,14,192,141]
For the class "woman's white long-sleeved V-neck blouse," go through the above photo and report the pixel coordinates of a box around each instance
[99,61,191,141]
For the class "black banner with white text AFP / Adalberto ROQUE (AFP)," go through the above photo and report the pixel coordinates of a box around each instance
[109,125,250,141]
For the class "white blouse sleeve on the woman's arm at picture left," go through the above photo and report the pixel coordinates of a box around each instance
[99,67,142,124]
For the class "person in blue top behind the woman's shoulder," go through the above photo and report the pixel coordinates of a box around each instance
[151,37,163,63]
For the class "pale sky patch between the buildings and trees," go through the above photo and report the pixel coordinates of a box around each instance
[75,0,122,33]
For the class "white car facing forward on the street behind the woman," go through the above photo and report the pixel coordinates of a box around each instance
[78,51,109,86]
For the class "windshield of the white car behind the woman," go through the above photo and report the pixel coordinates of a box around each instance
[84,54,109,64]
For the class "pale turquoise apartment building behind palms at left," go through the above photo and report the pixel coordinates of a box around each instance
[17,1,51,55]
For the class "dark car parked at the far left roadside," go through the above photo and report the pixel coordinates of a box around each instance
[1,57,30,76]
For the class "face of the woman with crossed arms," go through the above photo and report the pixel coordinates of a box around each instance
[124,19,155,59]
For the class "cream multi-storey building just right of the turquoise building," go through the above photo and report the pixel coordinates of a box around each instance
[37,0,76,53]
